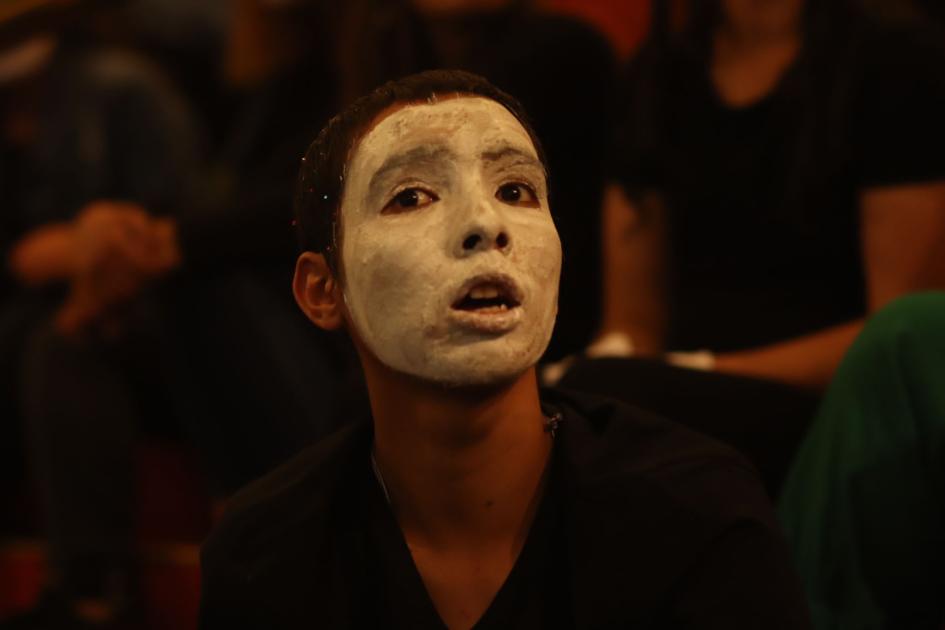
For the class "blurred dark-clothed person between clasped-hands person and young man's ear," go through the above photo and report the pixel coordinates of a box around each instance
[153,0,366,496]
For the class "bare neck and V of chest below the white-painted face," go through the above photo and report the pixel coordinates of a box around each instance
[359,344,552,628]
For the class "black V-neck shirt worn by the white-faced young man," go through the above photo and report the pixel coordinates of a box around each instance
[200,391,809,630]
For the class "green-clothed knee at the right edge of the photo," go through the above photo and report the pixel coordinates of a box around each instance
[779,292,945,630]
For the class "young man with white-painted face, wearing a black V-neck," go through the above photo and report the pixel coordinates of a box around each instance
[201,71,807,629]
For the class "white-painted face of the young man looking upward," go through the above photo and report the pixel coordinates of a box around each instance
[341,97,561,385]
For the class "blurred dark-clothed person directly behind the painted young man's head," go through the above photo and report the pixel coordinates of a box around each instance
[338,0,615,359]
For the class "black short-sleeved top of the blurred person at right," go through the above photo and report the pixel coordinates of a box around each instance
[613,25,945,351]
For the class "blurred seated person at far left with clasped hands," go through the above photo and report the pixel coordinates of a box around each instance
[0,2,200,628]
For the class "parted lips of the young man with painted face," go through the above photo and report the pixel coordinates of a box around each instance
[450,274,522,333]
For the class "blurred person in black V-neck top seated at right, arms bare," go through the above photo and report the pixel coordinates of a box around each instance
[603,0,945,388]
